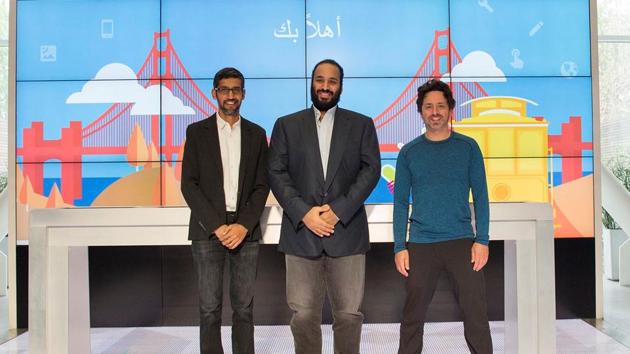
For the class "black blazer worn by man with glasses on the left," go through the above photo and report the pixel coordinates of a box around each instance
[181,114,269,241]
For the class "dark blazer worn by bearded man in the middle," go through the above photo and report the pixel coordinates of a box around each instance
[268,108,381,257]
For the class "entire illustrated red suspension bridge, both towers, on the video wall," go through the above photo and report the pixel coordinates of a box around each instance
[16,29,592,203]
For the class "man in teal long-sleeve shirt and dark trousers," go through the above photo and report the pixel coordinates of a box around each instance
[394,80,492,354]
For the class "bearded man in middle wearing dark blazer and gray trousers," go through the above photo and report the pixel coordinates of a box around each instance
[269,59,381,354]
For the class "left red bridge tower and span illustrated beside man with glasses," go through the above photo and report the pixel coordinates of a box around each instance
[17,30,217,202]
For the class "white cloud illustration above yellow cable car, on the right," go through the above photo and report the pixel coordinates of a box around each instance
[444,50,507,82]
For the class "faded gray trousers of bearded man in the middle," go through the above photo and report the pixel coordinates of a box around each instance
[285,254,365,354]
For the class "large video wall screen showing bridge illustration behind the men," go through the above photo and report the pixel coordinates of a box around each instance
[15,0,594,239]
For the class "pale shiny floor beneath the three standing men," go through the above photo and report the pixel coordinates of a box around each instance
[0,320,630,354]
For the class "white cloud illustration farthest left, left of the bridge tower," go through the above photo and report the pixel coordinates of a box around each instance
[66,63,144,103]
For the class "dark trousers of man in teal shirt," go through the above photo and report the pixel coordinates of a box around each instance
[398,239,492,354]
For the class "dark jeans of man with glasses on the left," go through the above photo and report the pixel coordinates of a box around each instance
[192,237,259,354]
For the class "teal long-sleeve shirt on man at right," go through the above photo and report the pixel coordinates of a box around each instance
[394,132,490,253]
